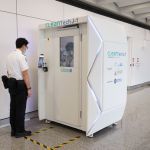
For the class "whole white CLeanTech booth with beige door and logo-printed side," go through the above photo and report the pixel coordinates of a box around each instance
[38,16,127,137]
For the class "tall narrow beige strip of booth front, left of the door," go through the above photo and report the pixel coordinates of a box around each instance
[43,30,55,121]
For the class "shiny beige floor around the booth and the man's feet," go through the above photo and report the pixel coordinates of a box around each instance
[0,87,150,150]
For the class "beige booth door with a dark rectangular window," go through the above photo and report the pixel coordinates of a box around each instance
[54,28,81,127]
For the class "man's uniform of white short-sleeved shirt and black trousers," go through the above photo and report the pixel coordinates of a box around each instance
[6,49,29,133]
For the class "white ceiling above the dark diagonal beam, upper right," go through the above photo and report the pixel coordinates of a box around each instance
[82,0,150,25]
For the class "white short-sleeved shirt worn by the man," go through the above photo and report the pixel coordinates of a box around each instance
[6,49,29,80]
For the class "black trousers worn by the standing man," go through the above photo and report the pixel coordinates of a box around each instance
[9,78,27,132]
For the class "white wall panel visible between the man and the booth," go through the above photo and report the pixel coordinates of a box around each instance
[18,16,45,112]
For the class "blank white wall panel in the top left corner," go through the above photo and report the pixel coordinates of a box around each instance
[0,0,16,13]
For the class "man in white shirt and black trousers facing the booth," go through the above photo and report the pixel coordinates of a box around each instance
[6,38,32,138]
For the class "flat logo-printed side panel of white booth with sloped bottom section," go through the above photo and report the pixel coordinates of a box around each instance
[87,42,127,136]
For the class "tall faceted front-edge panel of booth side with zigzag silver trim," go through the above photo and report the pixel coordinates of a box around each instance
[86,19,103,135]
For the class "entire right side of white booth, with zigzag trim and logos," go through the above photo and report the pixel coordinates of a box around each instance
[87,18,127,136]
